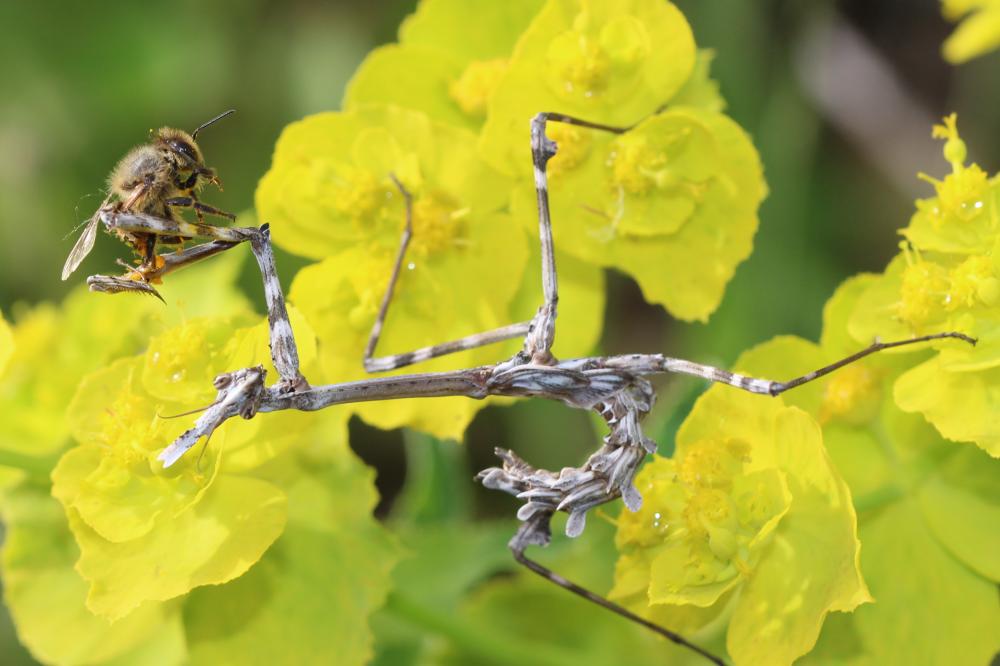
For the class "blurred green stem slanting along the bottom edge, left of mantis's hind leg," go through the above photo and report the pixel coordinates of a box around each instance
[385,592,579,666]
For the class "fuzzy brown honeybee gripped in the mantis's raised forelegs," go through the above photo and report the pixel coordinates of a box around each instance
[62,109,236,281]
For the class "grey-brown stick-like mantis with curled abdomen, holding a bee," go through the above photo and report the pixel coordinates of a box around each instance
[82,113,975,664]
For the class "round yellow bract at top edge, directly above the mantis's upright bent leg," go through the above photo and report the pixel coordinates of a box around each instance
[482,0,695,174]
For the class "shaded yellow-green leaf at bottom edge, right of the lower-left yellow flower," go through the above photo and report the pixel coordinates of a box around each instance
[184,442,397,666]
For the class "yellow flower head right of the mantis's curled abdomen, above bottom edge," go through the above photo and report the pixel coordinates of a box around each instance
[612,387,871,664]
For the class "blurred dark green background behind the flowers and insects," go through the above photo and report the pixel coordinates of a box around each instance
[0,0,1000,663]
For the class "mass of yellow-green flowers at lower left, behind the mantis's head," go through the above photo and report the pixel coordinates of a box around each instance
[0,254,395,664]
